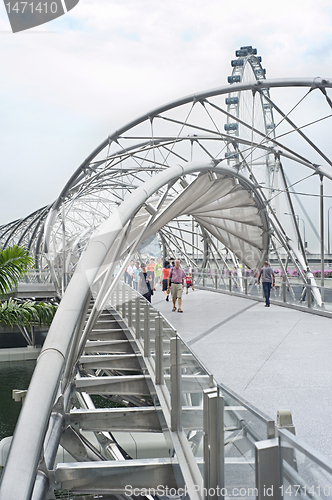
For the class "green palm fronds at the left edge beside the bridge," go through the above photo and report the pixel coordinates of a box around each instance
[0,245,57,345]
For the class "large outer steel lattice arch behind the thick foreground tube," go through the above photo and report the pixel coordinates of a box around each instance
[0,78,332,293]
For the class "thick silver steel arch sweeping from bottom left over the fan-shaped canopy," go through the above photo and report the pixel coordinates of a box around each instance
[0,161,269,500]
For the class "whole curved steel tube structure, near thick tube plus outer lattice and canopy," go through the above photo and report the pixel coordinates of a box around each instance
[0,46,332,500]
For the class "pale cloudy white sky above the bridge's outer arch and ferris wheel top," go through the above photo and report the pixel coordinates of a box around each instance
[0,0,332,229]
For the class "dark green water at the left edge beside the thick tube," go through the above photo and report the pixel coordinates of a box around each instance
[0,360,36,440]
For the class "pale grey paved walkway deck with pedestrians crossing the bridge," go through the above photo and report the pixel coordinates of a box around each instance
[152,286,332,459]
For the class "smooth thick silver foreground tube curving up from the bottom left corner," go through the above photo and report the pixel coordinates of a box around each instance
[0,161,269,500]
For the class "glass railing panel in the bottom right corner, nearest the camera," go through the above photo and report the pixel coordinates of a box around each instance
[279,431,332,500]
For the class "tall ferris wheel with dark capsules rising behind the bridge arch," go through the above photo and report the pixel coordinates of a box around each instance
[224,45,279,210]
